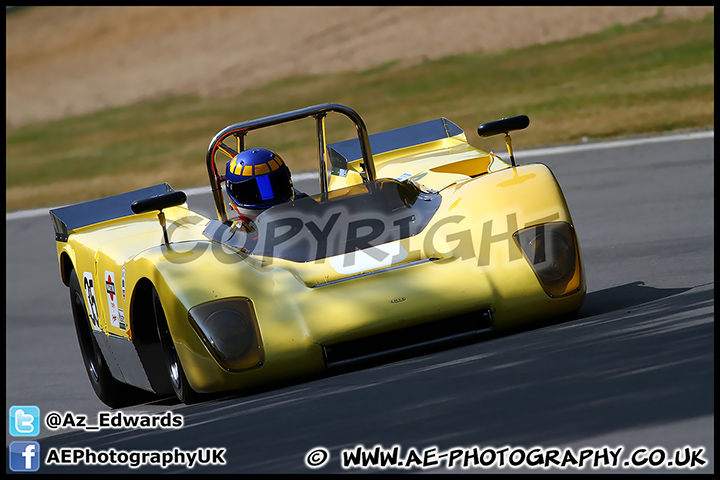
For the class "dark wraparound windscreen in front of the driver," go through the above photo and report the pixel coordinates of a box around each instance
[205,178,441,262]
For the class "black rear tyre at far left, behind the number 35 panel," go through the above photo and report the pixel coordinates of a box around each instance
[69,269,149,408]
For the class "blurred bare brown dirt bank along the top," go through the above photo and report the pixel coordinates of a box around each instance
[6,6,713,126]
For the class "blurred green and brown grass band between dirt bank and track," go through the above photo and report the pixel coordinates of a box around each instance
[6,15,715,210]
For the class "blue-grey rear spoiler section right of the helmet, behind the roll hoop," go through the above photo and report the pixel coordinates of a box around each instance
[328,117,465,171]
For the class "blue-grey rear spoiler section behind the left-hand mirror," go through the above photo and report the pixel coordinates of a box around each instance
[50,183,174,242]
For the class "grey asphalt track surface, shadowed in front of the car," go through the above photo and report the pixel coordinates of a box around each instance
[5,132,714,473]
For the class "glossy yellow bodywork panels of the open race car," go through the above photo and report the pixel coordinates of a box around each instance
[58,131,585,392]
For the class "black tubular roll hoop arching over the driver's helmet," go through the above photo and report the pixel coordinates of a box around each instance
[206,103,376,222]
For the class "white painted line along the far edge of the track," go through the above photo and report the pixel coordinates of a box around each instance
[5,130,715,222]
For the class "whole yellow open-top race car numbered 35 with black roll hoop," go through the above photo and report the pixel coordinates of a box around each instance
[50,103,585,407]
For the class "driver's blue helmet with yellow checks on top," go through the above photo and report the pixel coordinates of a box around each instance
[225,148,294,209]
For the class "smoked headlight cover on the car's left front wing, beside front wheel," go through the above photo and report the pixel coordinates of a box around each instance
[188,297,265,371]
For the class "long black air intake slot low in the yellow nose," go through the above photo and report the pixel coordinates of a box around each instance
[323,310,493,369]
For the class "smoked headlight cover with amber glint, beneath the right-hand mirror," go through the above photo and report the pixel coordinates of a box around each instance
[513,222,582,298]
